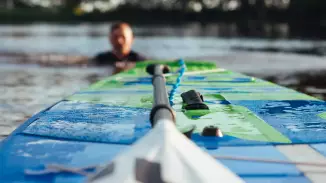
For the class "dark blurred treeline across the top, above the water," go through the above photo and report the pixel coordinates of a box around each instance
[0,0,326,24]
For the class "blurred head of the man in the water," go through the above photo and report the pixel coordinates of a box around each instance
[109,22,134,55]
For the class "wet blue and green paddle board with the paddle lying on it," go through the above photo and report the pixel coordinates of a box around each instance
[0,60,326,183]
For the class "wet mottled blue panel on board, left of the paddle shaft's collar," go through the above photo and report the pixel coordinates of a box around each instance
[23,102,151,144]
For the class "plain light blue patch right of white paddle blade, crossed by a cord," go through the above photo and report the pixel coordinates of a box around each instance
[204,146,310,183]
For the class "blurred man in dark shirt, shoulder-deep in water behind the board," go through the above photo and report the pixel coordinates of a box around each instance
[91,22,146,73]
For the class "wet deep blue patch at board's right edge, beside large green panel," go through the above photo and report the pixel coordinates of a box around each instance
[229,100,326,144]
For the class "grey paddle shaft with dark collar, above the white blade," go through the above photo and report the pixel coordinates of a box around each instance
[147,64,175,126]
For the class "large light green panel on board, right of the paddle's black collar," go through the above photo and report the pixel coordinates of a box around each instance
[177,104,291,143]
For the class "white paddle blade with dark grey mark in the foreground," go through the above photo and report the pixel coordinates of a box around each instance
[88,120,244,183]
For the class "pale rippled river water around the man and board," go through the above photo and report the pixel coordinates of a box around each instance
[0,23,326,139]
